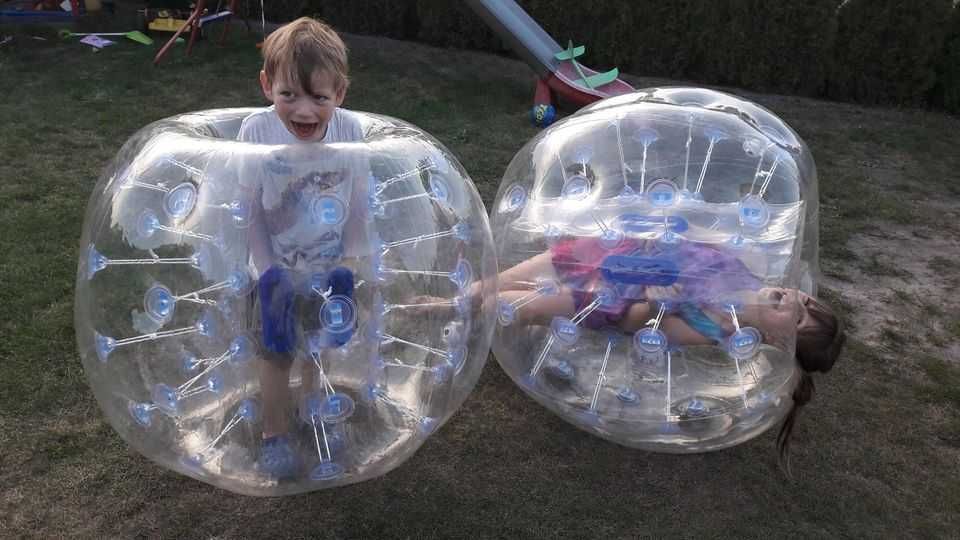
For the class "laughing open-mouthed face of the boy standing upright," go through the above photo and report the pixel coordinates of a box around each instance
[260,71,347,142]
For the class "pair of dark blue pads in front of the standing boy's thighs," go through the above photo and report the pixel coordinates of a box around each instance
[257,266,353,361]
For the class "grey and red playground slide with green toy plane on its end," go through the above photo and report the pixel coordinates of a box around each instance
[468,0,634,125]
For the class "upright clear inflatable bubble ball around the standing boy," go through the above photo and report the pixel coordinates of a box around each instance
[75,109,496,495]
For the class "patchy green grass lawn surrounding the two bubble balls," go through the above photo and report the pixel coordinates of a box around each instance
[0,14,960,538]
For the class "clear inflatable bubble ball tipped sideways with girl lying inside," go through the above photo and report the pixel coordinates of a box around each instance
[492,88,818,453]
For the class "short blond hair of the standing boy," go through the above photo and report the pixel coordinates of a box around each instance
[263,17,350,94]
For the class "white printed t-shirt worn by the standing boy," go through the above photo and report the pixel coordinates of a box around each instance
[237,106,369,274]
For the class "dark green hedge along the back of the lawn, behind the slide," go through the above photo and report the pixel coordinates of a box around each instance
[305,0,960,111]
